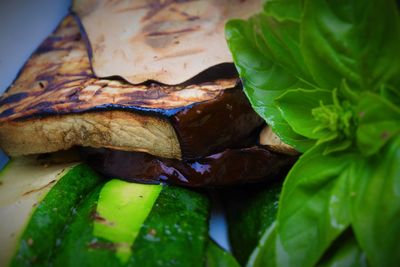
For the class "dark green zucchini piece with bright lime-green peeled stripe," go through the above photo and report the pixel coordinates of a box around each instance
[53,180,208,266]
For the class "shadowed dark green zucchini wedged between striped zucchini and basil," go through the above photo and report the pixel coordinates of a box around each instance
[223,181,282,265]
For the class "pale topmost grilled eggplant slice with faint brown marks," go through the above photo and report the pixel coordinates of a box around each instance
[73,0,261,84]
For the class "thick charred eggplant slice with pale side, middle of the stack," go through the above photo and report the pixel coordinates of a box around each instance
[0,16,262,159]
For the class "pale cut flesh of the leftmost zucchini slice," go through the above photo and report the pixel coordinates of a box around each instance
[0,156,76,266]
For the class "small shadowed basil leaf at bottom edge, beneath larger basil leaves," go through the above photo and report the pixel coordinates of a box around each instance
[317,231,368,267]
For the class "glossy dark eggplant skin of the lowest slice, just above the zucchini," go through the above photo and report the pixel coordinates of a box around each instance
[82,146,297,187]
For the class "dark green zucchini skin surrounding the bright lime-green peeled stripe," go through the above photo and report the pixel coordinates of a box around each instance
[52,186,209,267]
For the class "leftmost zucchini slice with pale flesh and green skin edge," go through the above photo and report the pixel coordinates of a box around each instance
[0,157,101,266]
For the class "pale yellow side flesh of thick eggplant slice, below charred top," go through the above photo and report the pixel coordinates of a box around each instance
[0,111,181,159]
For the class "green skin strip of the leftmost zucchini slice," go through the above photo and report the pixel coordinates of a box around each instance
[10,164,102,267]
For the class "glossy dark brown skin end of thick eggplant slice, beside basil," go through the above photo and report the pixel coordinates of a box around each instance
[171,84,263,159]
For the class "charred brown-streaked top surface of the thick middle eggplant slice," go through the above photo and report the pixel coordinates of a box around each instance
[0,16,237,122]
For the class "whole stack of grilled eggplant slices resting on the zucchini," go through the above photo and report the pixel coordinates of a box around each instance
[0,0,295,187]
